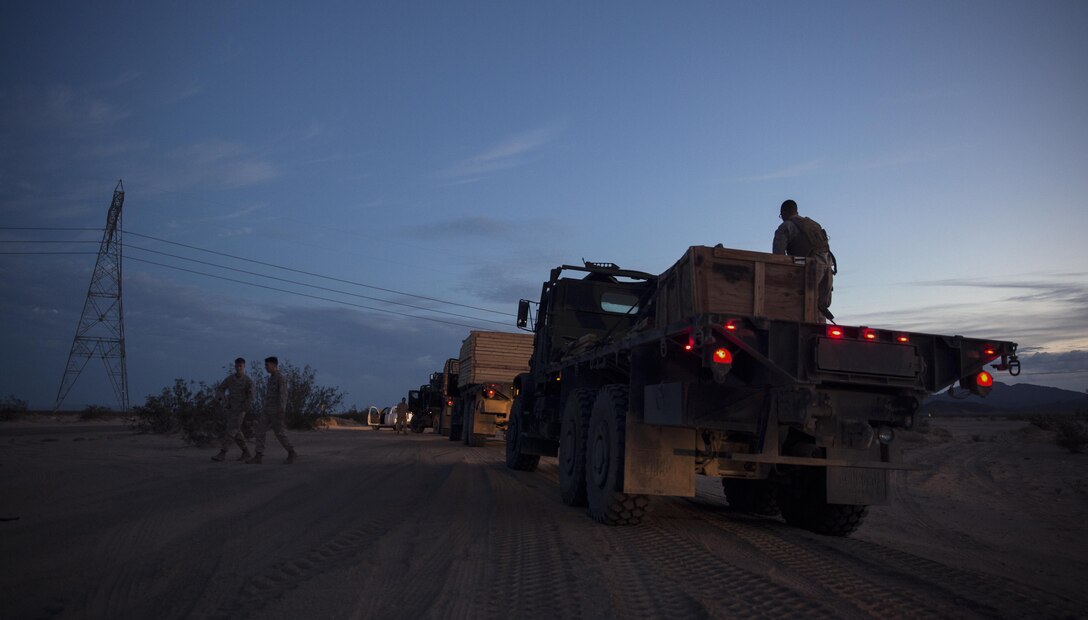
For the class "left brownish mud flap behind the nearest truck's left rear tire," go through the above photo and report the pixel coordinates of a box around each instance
[623,417,696,497]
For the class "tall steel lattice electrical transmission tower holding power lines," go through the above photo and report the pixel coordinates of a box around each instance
[54,181,128,411]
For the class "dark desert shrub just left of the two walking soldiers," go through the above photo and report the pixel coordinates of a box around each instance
[133,379,217,446]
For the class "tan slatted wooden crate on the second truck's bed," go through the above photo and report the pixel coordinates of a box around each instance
[457,332,533,387]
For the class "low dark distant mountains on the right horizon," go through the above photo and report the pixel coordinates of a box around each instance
[923,383,1088,414]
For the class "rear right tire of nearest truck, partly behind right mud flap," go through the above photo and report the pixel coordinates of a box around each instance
[778,468,869,536]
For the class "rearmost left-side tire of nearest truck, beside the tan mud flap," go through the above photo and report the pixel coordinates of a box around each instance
[585,385,650,525]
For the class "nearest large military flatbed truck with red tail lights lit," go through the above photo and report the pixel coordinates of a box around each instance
[506,247,1019,535]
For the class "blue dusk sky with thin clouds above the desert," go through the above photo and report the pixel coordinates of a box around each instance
[0,0,1088,408]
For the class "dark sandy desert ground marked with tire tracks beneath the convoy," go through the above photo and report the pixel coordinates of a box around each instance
[0,420,1088,619]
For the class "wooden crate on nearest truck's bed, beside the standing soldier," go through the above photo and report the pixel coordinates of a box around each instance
[657,246,819,326]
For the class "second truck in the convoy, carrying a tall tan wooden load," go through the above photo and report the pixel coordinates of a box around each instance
[449,331,533,446]
